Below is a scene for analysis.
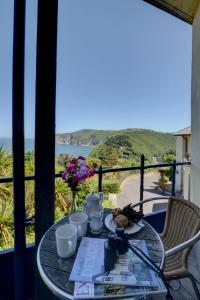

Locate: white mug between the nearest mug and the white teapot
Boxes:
[69,212,88,238]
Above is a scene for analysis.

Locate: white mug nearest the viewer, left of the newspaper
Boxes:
[56,224,77,258]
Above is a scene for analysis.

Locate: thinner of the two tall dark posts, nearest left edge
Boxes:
[12,0,26,300]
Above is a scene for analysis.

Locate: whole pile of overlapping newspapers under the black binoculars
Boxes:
[69,237,166,299]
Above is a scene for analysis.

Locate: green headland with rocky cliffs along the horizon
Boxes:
[56,128,175,157]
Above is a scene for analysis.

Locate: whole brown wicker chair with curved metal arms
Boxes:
[132,196,200,299]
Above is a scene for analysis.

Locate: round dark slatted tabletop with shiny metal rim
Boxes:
[37,209,164,299]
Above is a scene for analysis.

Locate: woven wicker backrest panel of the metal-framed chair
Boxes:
[161,197,200,260]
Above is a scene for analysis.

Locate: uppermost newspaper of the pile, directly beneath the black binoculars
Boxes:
[69,237,158,286]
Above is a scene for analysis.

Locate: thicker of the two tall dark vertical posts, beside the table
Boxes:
[34,0,58,300]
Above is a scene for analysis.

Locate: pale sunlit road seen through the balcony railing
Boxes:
[112,172,166,213]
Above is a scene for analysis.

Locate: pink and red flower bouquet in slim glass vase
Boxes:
[62,156,97,214]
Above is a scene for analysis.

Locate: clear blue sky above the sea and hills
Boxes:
[0,0,192,137]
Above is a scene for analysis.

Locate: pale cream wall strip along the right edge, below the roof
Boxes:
[191,2,200,206]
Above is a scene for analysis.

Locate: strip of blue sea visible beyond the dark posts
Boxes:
[0,137,94,157]
